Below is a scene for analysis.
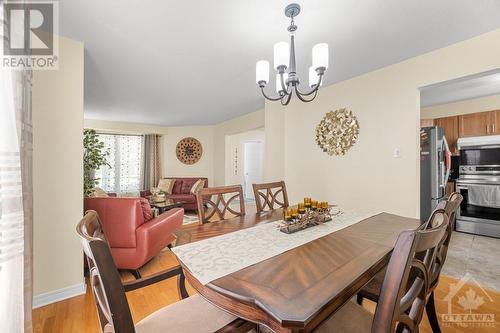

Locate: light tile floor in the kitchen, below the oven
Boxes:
[442,232,500,291]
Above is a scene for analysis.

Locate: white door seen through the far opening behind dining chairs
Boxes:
[243,141,263,199]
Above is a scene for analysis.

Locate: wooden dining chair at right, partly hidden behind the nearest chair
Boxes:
[357,192,463,333]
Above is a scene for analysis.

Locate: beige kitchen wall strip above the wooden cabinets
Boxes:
[421,95,500,119]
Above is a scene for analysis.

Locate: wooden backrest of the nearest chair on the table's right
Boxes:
[372,210,448,333]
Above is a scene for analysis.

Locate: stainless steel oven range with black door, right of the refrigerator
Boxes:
[456,136,500,238]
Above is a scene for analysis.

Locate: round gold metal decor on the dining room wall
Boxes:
[316,108,359,156]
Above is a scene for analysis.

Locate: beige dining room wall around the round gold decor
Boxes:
[265,30,500,217]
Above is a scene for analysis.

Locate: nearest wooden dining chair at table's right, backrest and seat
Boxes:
[316,209,449,333]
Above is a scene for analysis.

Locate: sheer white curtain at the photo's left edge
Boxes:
[0,44,32,332]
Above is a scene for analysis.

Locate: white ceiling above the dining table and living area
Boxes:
[60,0,500,125]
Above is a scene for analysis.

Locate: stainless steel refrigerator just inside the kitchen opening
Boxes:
[420,127,451,221]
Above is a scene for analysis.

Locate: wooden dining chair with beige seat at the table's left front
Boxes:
[76,211,255,333]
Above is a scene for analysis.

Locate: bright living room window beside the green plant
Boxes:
[96,134,143,196]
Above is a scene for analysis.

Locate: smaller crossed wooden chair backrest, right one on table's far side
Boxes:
[253,181,288,213]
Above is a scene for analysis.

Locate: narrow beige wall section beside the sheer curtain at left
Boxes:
[32,38,84,296]
